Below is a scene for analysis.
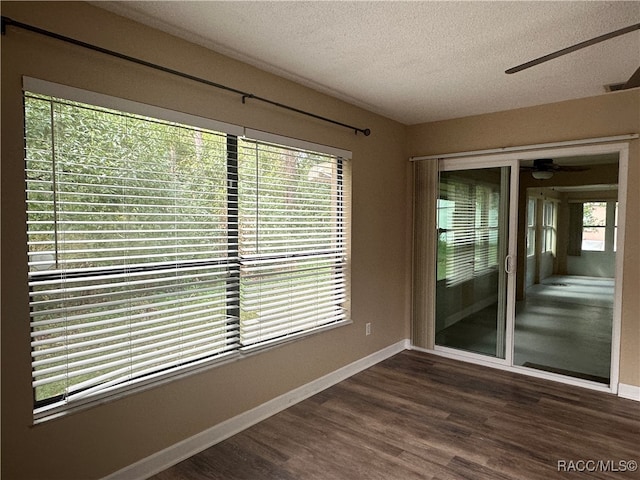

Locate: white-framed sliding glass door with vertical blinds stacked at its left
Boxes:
[411,143,629,393]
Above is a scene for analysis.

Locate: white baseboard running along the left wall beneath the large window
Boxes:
[103,340,410,480]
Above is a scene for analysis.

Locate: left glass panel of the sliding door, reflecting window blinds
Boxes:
[435,167,510,358]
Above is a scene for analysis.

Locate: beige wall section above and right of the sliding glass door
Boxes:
[408,89,640,386]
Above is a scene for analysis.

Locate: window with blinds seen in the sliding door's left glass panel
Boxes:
[437,172,500,286]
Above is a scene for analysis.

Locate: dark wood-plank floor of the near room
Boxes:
[152,351,640,480]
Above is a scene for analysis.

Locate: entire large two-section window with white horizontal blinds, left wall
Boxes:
[24,83,349,416]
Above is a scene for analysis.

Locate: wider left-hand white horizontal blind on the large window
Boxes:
[25,93,239,405]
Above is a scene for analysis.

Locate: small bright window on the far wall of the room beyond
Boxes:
[582,202,618,252]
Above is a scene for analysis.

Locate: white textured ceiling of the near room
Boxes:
[94,1,640,125]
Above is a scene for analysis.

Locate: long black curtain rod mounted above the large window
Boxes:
[2,16,371,137]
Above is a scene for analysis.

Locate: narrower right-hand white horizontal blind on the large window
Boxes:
[238,141,348,347]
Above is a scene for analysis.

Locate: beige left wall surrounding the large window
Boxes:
[2,2,410,480]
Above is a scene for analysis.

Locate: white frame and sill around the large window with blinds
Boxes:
[23,77,351,421]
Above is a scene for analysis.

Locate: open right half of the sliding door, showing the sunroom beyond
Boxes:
[513,153,619,385]
